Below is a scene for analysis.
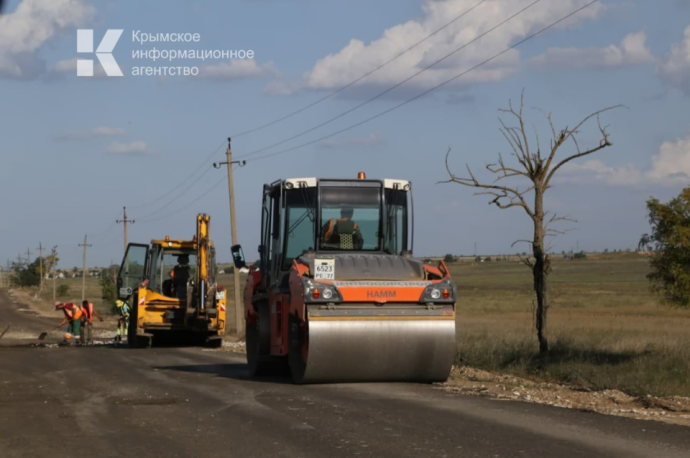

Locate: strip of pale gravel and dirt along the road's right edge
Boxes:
[439,367,690,426]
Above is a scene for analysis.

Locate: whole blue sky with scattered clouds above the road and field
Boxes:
[0,0,690,268]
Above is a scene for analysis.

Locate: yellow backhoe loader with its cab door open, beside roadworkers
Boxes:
[117,214,226,347]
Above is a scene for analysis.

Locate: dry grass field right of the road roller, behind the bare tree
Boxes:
[450,253,690,396]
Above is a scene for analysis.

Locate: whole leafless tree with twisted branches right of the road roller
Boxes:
[442,91,620,353]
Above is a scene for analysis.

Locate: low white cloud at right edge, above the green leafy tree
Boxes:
[556,137,690,186]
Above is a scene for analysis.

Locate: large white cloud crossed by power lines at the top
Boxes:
[298,0,604,95]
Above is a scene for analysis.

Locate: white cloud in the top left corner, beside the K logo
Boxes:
[0,0,95,79]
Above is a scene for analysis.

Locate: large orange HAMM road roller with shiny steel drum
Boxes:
[231,172,457,384]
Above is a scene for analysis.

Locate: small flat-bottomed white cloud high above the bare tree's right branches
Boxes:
[528,32,655,69]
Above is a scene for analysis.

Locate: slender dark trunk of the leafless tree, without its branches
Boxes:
[532,189,549,354]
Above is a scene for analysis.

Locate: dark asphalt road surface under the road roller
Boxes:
[0,293,690,458]
